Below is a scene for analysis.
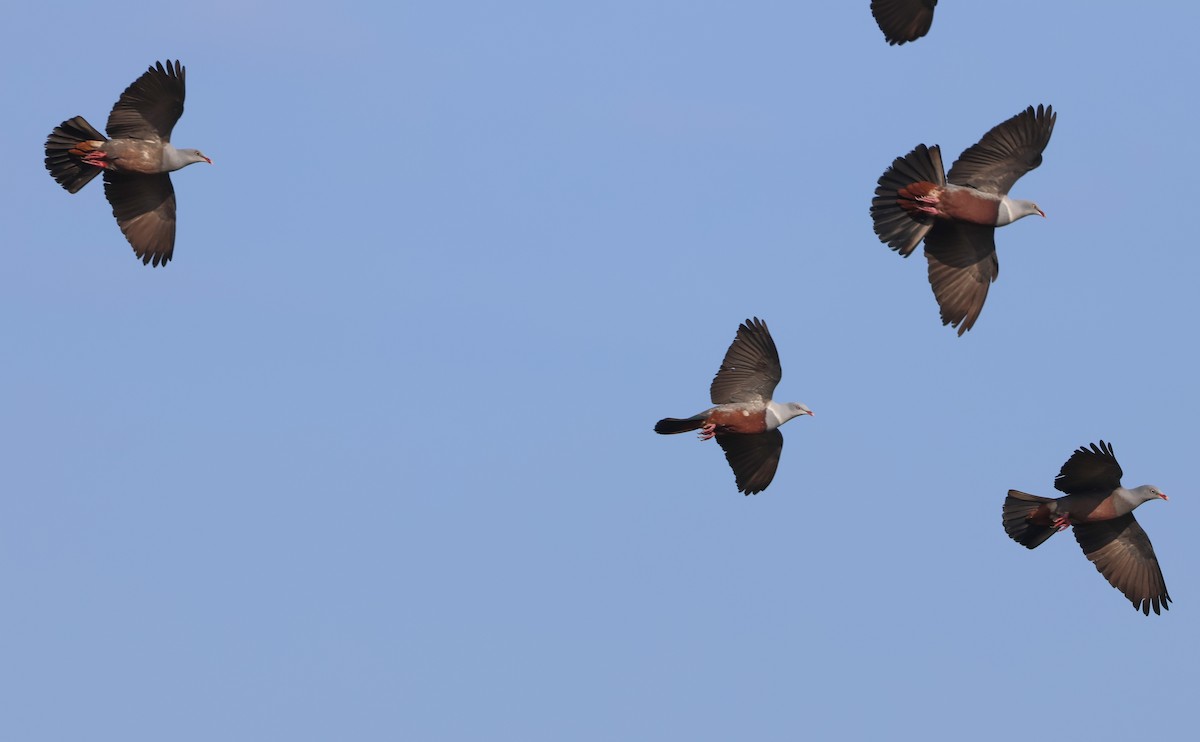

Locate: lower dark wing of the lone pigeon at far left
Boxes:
[104,170,175,268]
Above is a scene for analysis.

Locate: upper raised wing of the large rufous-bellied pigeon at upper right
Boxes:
[946,104,1056,196]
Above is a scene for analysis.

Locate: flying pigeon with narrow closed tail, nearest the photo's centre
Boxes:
[654,317,812,495]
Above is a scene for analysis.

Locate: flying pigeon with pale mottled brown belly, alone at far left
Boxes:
[46,60,212,268]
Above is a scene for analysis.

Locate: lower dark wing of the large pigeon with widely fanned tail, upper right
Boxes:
[925,221,1000,336]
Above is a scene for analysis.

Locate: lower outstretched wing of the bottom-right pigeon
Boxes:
[1075,513,1171,616]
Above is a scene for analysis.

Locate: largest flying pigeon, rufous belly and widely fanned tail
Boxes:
[871,104,1056,336]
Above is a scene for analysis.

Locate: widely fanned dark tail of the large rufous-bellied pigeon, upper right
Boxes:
[871,144,946,257]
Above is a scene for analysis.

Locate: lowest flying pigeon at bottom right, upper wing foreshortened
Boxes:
[1004,441,1171,616]
